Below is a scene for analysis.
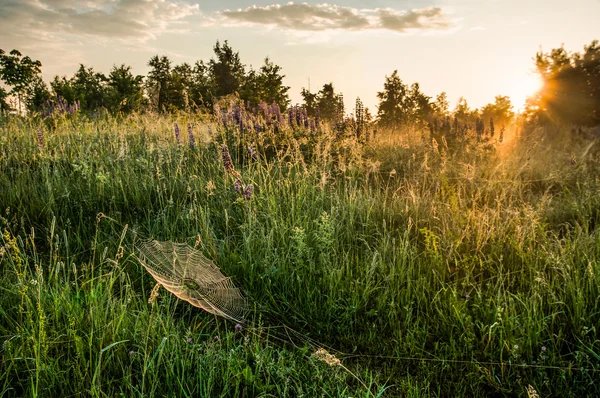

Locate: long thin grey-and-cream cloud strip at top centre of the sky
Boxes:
[221,3,455,33]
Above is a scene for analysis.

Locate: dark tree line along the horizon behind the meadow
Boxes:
[0,40,600,129]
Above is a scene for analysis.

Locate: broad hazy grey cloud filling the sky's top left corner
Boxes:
[0,0,199,47]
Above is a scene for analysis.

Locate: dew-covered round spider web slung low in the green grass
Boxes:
[136,240,248,323]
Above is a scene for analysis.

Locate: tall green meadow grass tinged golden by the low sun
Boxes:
[0,110,600,397]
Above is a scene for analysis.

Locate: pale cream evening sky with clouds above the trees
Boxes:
[0,0,600,112]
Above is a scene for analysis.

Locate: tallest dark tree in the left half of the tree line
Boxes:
[208,40,245,97]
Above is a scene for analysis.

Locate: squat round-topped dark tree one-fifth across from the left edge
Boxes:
[107,64,143,113]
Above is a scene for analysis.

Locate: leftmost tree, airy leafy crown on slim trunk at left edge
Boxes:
[0,50,42,113]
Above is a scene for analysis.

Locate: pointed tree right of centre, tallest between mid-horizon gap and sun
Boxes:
[377,70,408,128]
